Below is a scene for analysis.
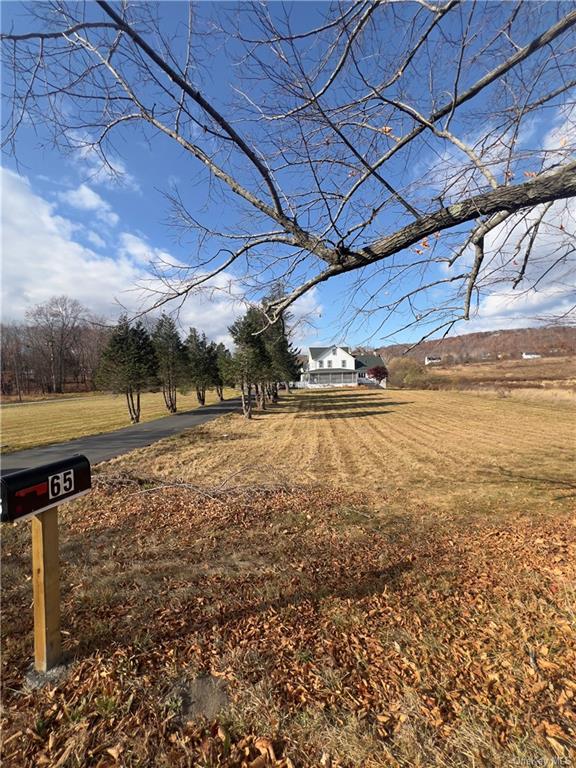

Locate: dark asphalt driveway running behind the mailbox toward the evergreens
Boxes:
[0,398,240,475]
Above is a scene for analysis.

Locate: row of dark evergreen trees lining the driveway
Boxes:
[96,308,298,423]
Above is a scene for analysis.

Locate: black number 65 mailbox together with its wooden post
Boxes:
[0,455,92,672]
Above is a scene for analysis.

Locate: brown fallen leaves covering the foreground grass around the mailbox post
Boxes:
[3,478,576,768]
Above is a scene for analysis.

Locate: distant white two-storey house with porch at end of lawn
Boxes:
[300,345,386,389]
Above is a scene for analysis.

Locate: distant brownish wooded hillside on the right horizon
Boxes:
[377,326,576,364]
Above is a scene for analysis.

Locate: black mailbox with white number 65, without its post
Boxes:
[0,454,92,523]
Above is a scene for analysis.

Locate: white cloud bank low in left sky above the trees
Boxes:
[0,169,264,343]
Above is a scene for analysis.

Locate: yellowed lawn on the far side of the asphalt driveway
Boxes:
[0,390,236,453]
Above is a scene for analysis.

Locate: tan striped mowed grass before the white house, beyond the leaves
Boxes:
[104,389,576,515]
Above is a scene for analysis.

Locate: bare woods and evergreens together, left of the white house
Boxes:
[1,296,299,423]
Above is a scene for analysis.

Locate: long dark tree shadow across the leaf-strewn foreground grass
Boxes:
[57,510,414,657]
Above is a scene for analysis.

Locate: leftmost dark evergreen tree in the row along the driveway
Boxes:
[97,316,158,424]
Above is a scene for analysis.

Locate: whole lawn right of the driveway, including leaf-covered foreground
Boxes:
[2,389,576,768]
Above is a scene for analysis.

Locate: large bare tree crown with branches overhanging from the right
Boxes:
[2,0,576,333]
